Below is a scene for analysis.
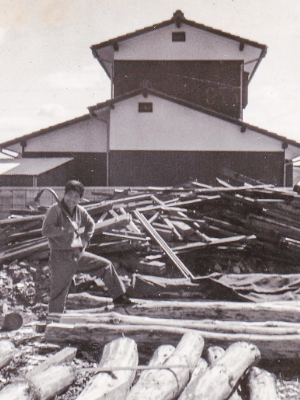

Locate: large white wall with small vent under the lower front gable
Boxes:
[110,95,283,152]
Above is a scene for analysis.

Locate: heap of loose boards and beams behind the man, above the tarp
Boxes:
[0,181,300,278]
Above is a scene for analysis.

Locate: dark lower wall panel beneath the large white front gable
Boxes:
[110,151,283,186]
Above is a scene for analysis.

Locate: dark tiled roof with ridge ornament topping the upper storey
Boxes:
[91,10,267,80]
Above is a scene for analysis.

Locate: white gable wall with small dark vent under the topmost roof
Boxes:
[98,23,261,77]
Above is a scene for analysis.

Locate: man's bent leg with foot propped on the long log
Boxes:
[76,251,126,299]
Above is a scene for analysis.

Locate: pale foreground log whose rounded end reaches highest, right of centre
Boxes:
[126,332,204,400]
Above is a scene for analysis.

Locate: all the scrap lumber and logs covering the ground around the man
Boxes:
[0,180,300,400]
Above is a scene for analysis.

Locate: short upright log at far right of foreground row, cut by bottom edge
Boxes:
[247,367,279,400]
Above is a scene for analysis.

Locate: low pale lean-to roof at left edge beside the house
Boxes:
[0,157,73,176]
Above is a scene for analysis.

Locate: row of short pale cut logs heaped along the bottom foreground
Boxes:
[0,330,299,400]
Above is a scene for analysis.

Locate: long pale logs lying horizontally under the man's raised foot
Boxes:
[45,300,300,360]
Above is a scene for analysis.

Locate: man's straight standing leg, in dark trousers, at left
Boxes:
[49,250,76,313]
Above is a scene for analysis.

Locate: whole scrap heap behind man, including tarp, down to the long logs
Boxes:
[0,181,300,307]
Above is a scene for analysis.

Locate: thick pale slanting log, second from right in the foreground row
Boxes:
[184,342,260,400]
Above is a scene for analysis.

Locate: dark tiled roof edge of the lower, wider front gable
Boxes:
[88,87,300,148]
